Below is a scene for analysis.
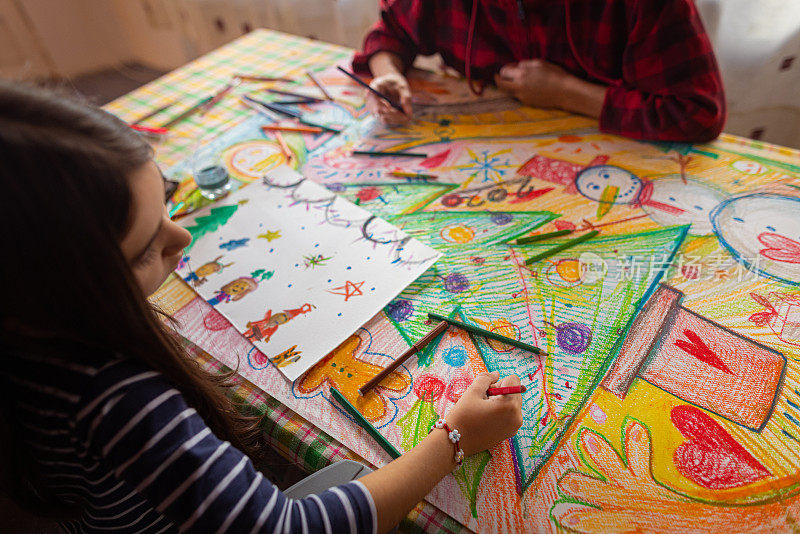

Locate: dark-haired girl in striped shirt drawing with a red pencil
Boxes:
[0,81,522,533]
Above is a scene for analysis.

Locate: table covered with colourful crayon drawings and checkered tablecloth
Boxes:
[107,31,800,532]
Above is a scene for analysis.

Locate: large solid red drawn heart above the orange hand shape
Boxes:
[670,405,770,489]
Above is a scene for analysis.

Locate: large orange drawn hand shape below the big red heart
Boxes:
[550,419,800,534]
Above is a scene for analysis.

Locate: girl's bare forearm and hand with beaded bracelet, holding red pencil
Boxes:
[359,372,522,532]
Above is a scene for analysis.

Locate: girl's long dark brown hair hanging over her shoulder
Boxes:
[0,80,264,510]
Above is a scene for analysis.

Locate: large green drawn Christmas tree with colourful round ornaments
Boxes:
[385,212,686,491]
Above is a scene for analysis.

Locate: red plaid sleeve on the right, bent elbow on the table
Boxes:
[600,0,726,142]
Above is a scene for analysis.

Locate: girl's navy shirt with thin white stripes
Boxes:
[0,349,377,534]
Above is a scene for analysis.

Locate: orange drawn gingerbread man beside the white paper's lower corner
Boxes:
[297,335,411,422]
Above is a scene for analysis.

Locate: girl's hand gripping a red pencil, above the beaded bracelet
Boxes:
[445,371,522,456]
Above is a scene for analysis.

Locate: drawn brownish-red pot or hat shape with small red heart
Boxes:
[601,284,786,431]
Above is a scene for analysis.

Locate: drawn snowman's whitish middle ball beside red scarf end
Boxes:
[642,174,727,235]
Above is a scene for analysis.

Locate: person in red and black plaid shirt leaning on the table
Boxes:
[353,0,726,142]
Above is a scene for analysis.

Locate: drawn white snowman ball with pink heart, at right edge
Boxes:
[711,193,800,285]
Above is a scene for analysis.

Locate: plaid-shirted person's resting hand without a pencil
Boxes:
[494,59,573,108]
